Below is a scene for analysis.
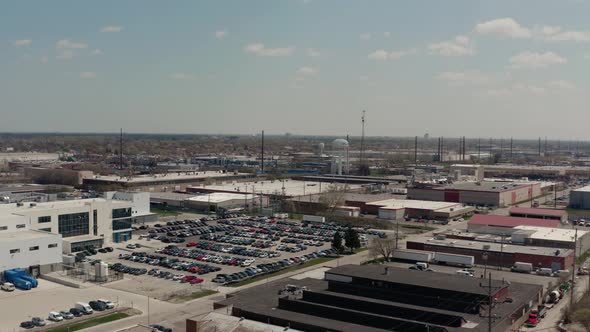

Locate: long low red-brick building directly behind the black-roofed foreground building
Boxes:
[406,236,574,271]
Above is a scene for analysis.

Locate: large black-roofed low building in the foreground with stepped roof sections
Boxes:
[214,265,542,332]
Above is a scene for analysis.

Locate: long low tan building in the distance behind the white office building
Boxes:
[83,171,255,192]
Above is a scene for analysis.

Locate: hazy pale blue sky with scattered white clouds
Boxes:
[0,0,590,139]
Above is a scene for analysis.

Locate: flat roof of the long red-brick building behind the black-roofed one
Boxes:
[408,236,573,257]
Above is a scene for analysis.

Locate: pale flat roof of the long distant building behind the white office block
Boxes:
[87,171,248,183]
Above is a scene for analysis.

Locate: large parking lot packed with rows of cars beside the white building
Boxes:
[89,217,385,300]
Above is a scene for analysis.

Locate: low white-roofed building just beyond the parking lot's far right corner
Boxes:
[367,199,475,220]
